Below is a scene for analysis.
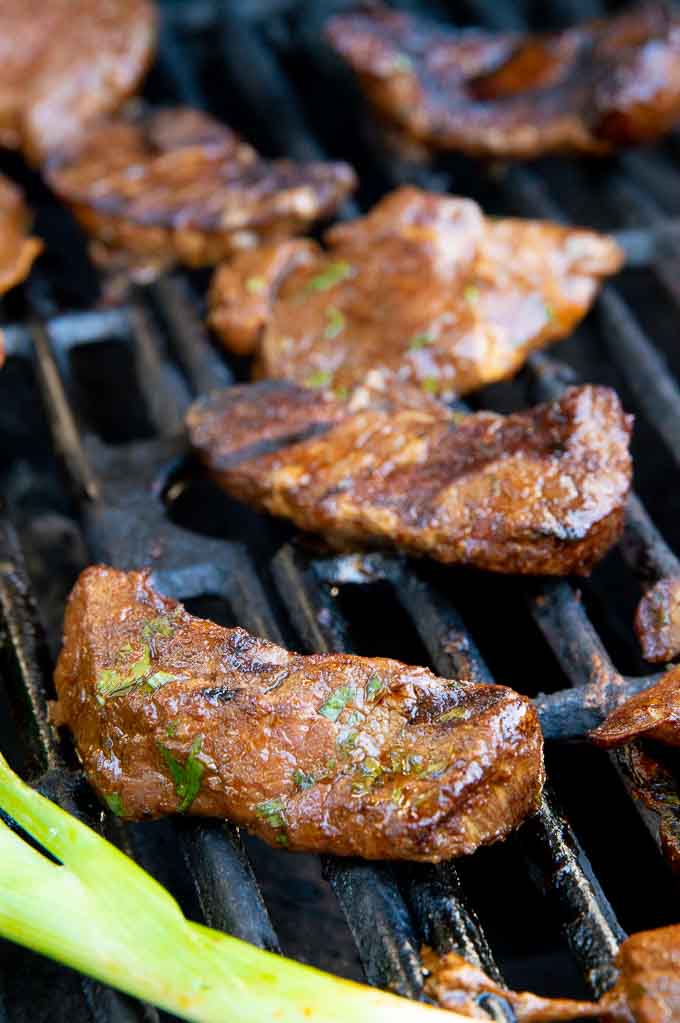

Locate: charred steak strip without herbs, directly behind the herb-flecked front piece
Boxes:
[187,382,631,575]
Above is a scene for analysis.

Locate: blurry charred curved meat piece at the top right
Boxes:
[327,2,680,159]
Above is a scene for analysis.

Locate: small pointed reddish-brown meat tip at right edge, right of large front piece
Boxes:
[590,667,680,747]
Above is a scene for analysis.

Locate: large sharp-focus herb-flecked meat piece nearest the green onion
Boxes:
[54,567,544,861]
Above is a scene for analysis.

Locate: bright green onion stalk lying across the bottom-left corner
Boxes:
[0,756,464,1023]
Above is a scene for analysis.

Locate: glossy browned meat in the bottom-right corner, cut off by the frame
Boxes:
[423,926,680,1023]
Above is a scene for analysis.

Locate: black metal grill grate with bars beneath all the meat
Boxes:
[0,0,680,1023]
